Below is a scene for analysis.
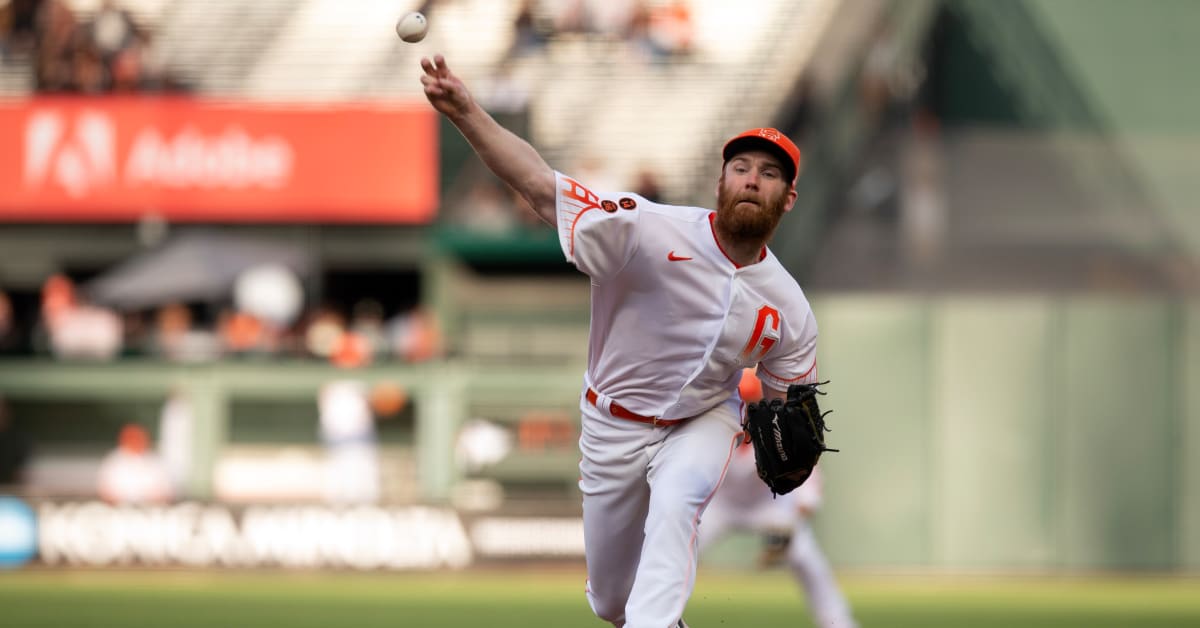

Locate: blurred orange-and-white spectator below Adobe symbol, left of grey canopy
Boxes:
[42,274,124,360]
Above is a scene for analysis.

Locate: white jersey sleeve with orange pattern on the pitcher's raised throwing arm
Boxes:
[554,172,641,279]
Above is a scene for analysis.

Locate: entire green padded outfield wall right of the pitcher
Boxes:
[816,297,1200,570]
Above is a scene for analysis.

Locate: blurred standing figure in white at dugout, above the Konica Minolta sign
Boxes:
[317,379,379,504]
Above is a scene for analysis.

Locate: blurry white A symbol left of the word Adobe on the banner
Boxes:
[24,110,116,198]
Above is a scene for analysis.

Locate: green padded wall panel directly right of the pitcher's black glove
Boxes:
[815,297,934,566]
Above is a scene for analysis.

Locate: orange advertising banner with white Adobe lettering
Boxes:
[0,98,438,223]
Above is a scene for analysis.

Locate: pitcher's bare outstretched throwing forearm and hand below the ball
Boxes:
[421,54,554,225]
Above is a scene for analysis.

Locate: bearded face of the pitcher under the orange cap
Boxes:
[716,150,796,240]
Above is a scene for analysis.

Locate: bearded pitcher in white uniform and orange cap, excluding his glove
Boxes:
[421,55,817,628]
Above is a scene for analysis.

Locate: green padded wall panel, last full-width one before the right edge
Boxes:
[1056,299,1176,569]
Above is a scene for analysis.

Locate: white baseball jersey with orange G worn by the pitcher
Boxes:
[556,173,817,419]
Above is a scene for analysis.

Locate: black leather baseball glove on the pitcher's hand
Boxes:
[742,382,836,495]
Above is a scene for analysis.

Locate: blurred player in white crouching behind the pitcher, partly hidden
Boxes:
[700,369,858,628]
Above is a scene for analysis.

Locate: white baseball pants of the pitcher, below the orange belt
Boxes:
[580,395,740,628]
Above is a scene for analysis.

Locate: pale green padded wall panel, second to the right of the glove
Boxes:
[930,298,1055,569]
